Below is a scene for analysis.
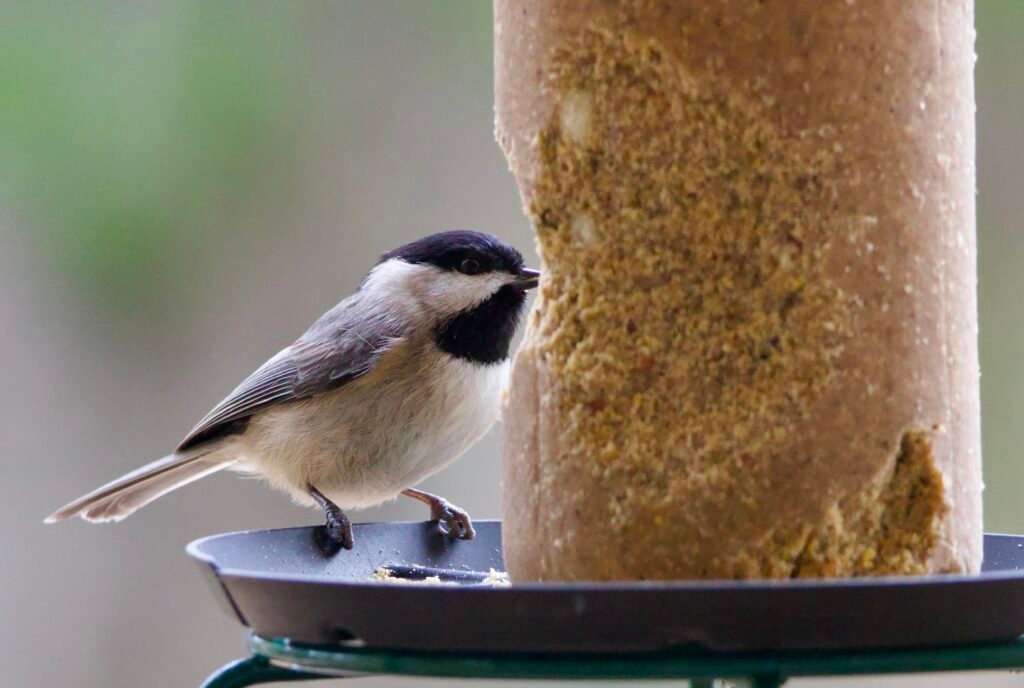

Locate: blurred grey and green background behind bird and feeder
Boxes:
[0,0,1024,688]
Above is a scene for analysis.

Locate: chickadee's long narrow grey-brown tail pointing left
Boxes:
[46,447,236,523]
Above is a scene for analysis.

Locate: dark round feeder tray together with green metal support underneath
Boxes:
[188,521,1024,688]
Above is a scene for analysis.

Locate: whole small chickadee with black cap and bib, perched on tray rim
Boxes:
[46,231,540,549]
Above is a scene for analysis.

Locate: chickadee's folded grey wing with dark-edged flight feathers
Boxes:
[178,321,402,452]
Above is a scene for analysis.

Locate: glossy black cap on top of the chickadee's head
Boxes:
[381,230,523,274]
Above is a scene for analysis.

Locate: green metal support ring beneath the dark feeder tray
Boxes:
[203,635,1024,688]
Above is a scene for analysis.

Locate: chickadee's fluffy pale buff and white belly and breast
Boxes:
[234,353,508,508]
